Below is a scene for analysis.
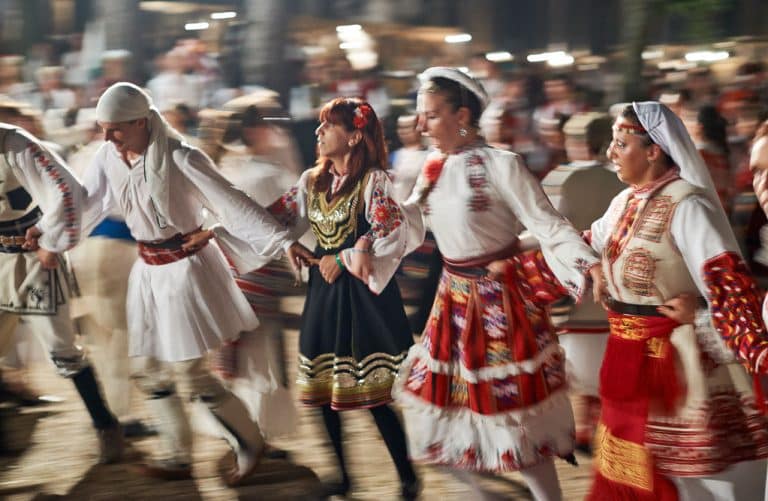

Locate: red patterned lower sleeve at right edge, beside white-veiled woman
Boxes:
[703,252,768,372]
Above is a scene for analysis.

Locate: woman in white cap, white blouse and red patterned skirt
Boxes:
[395,67,600,500]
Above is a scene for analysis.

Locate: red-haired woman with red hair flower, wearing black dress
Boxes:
[270,98,419,499]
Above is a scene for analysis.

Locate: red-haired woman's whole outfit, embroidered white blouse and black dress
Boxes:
[269,166,413,410]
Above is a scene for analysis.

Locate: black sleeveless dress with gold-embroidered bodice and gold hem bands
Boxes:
[297,176,413,410]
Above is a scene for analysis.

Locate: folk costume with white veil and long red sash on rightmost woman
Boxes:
[589,102,768,500]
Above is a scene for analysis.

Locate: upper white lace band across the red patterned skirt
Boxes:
[401,343,565,384]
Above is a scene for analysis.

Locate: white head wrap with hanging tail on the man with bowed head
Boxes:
[96,82,181,228]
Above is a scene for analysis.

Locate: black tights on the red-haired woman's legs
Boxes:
[322,405,416,485]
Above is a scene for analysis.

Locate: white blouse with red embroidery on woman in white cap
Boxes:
[404,145,599,297]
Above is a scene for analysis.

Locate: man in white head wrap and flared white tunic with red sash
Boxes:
[83,82,298,485]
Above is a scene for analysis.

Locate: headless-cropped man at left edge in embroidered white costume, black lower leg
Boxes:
[0,117,123,463]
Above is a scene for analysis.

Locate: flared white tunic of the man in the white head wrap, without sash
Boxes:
[83,142,287,361]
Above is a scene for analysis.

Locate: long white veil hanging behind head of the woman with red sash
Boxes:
[632,101,739,250]
